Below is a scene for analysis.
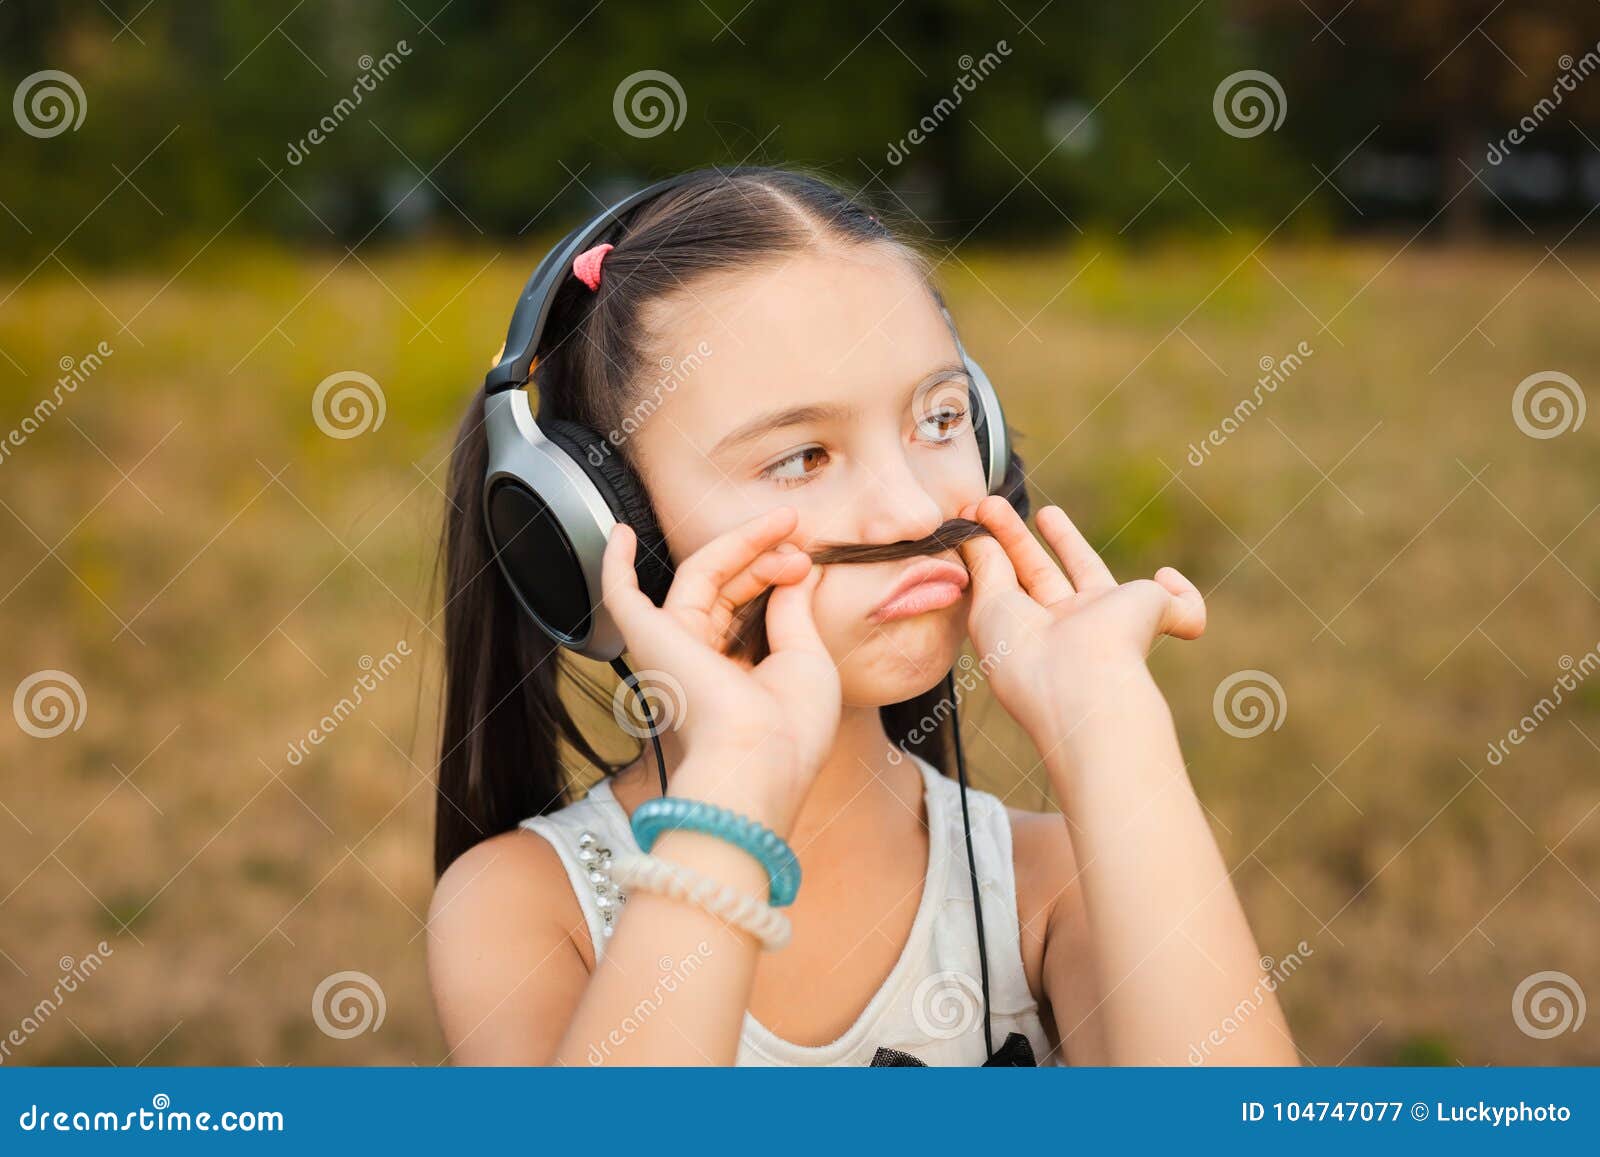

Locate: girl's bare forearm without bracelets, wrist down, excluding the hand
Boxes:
[1038,664,1298,1064]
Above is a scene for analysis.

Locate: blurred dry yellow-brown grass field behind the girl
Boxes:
[0,237,1600,1064]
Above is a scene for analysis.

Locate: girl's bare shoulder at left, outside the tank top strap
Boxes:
[427,827,594,1064]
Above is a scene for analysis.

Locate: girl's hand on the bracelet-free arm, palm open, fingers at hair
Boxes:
[960,494,1205,751]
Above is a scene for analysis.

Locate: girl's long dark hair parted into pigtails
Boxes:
[434,166,1027,874]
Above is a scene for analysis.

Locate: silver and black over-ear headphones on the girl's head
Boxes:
[483,173,1011,663]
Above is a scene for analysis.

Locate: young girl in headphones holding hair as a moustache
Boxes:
[429,168,1296,1066]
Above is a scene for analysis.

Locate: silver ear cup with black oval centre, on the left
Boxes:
[483,389,622,661]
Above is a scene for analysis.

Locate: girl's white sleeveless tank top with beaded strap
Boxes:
[522,755,1050,1066]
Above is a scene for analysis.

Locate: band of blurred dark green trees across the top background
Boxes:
[25,0,1574,264]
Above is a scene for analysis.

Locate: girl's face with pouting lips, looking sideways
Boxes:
[626,246,986,706]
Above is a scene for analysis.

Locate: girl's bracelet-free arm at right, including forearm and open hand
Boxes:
[962,498,1298,1064]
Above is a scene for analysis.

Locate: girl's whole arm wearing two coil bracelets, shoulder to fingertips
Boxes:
[429,507,840,1064]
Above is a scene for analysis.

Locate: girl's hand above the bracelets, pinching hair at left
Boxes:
[602,507,840,819]
